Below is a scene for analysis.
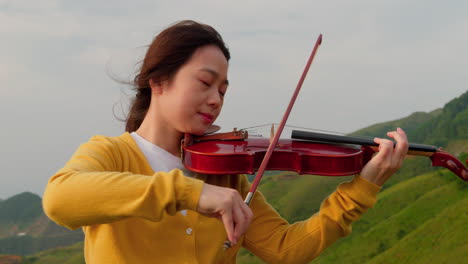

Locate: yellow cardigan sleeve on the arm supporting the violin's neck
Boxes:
[243,176,380,263]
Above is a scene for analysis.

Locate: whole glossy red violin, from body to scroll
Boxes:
[182,127,468,181]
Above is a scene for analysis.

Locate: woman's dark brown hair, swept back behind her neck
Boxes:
[125,20,231,132]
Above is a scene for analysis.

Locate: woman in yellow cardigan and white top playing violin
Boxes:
[43,21,408,264]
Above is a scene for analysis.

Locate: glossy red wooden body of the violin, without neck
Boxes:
[182,138,373,176]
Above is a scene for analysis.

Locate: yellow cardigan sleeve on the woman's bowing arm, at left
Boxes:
[43,137,203,229]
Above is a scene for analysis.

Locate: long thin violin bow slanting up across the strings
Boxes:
[224,34,322,249]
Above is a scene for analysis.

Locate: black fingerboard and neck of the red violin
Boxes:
[291,130,438,157]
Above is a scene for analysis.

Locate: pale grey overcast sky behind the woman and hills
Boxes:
[0,0,468,199]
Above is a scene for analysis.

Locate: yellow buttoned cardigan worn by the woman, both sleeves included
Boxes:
[43,133,380,264]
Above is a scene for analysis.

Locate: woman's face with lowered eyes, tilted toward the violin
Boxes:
[155,45,228,135]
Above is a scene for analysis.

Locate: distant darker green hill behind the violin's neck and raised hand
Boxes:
[350,91,468,188]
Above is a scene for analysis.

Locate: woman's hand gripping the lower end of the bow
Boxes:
[197,183,253,245]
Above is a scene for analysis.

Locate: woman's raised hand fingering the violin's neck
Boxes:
[361,128,408,186]
